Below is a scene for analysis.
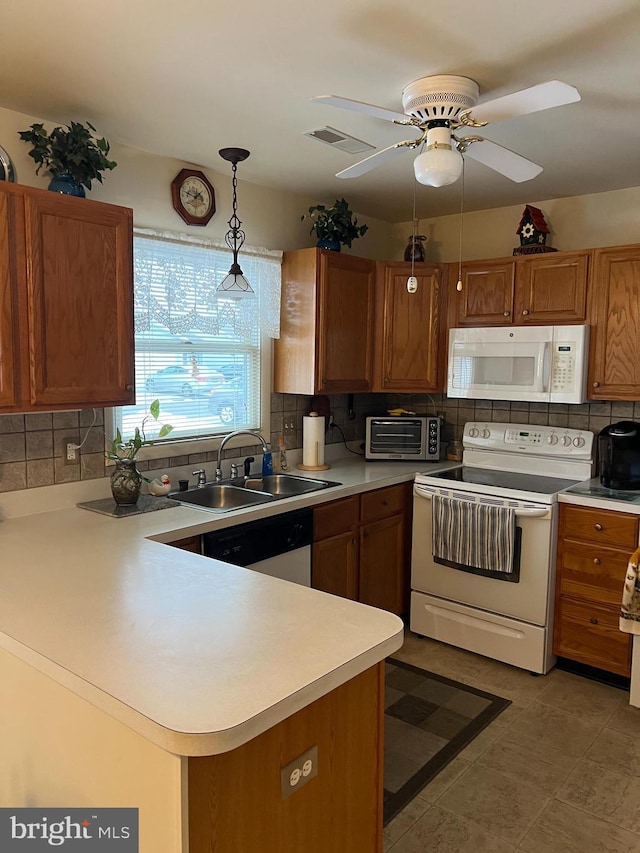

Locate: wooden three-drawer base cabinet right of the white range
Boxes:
[553,504,639,677]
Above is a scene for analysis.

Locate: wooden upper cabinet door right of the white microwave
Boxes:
[587,245,640,400]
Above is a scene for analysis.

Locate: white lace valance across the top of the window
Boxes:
[134,228,282,340]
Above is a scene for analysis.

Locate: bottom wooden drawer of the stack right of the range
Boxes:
[553,597,631,676]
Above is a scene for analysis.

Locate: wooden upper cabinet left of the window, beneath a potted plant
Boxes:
[0,182,135,412]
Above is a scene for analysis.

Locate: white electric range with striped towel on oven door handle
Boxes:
[410,422,594,673]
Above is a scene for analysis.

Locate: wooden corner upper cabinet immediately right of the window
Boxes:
[274,249,375,394]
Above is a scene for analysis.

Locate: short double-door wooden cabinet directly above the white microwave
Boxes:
[449,252,590,326]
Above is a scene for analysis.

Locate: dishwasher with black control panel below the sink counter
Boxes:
[202,509,313,586]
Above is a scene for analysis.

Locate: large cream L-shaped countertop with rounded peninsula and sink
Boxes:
[0,459,451,755]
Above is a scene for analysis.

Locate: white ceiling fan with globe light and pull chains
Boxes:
[312,74,580,187]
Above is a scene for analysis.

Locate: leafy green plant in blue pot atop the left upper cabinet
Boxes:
[18,121,117,196]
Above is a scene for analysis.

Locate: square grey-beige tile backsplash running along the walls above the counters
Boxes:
[0,394,640,492]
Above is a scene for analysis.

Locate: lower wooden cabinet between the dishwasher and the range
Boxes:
[311,483,412,615]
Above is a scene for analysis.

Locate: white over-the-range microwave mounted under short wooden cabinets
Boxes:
[447,326,589,403]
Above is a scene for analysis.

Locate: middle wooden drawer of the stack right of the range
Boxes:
[558,539,630,607]
